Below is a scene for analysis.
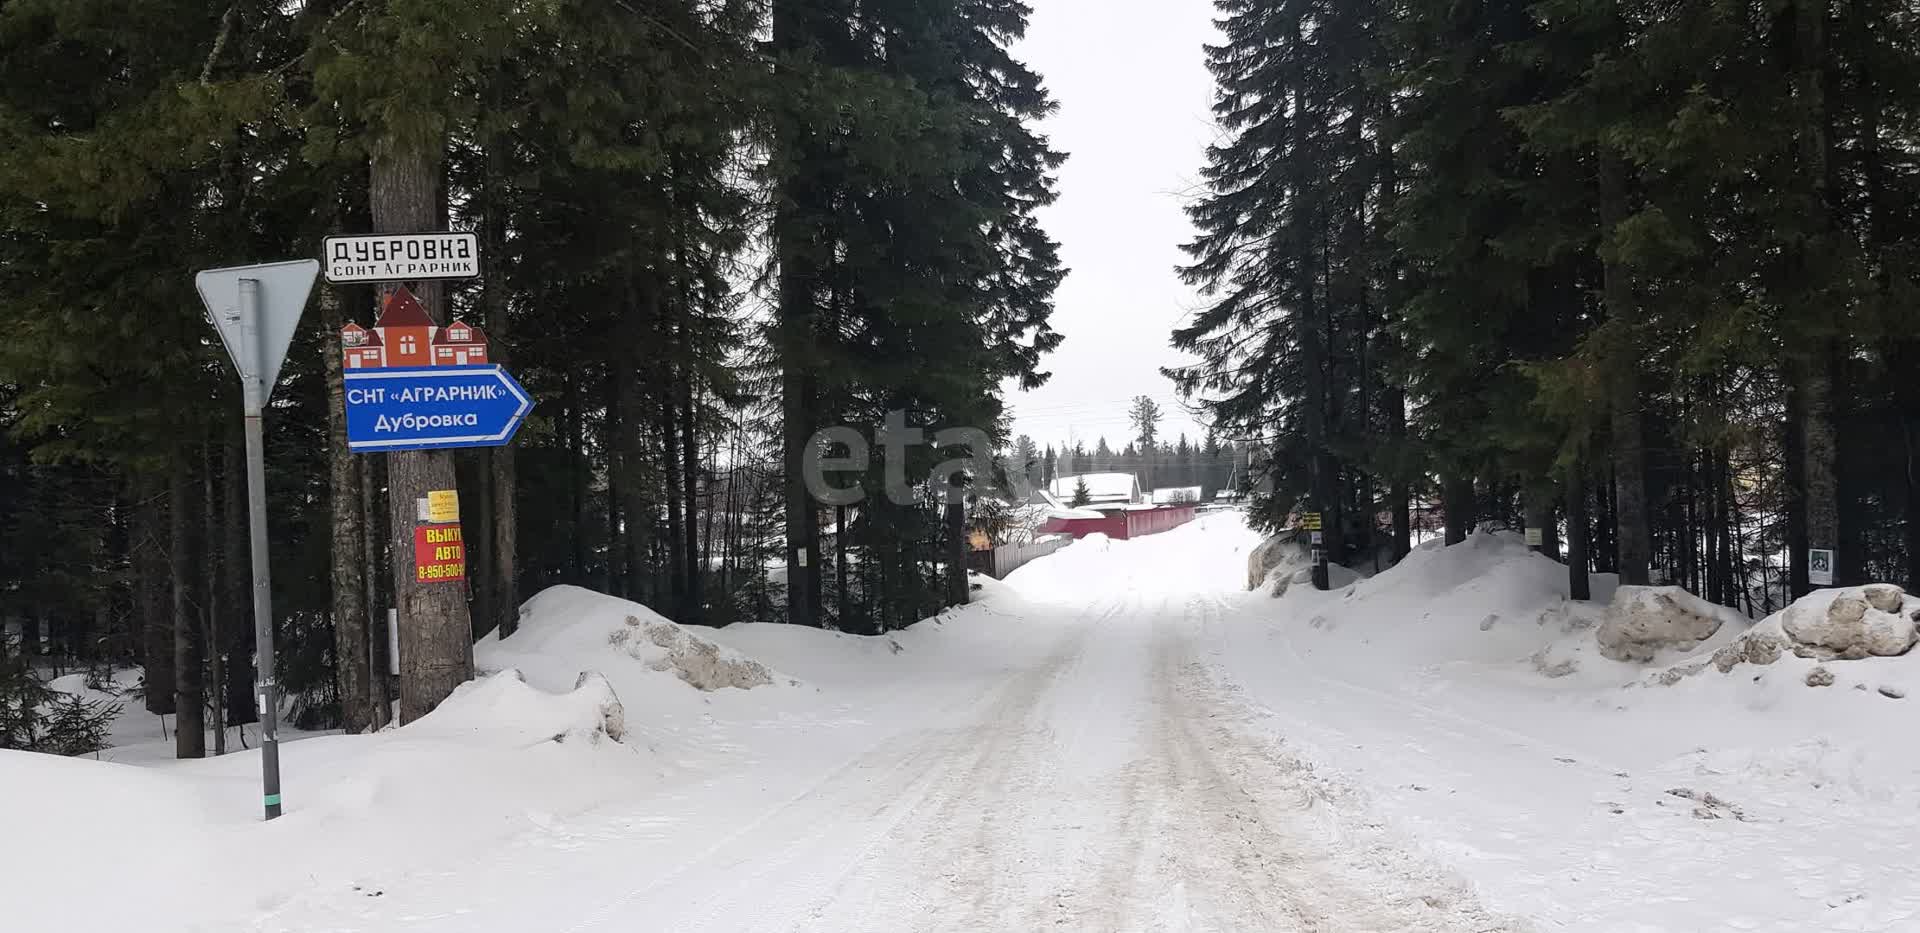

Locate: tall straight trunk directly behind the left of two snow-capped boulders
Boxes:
[1599,152,1653,586]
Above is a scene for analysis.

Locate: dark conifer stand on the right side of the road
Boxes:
[1169,0,1920,614]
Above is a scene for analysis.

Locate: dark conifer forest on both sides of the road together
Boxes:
[0,0,1920,756]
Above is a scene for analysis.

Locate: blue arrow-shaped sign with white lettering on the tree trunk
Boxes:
[346,367,534,453]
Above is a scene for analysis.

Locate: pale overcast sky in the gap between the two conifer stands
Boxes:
[1008,0,1213,449]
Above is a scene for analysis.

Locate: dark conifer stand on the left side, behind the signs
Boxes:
[0,0,1064,756]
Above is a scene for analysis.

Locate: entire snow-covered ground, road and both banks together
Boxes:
[0,514,1920,933]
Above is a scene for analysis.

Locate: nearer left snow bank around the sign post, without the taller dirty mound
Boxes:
[0,656,668,931]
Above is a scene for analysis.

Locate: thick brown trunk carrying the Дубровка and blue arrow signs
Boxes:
[371,140,474,722]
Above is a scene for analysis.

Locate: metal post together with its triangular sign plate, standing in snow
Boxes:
[194,259,321,820]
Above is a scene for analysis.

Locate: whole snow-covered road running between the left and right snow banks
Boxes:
[261,533,1507,933]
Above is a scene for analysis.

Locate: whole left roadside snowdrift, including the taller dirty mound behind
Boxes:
[0,587,806,929]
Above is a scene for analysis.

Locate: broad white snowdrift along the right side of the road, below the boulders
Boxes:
[1221,534,1920,933]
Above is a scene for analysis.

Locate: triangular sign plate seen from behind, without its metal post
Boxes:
[194,259,321,411]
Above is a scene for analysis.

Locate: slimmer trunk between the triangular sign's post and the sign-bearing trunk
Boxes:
[321,286,372,735]
